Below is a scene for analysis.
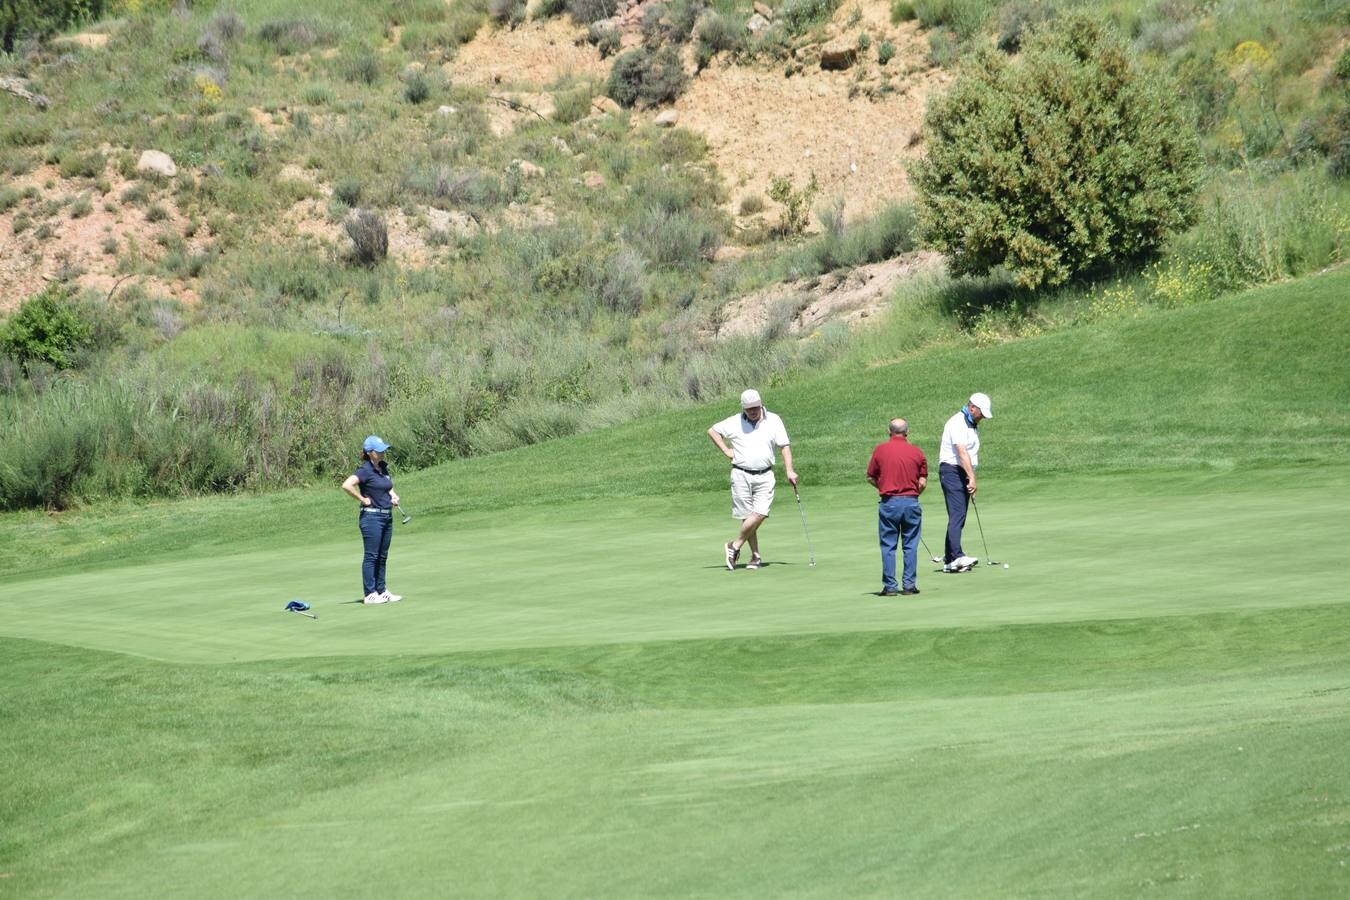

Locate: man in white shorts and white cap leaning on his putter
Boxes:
[707,390,797,572]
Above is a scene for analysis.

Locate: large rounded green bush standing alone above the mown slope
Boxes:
[915,16,1200,287]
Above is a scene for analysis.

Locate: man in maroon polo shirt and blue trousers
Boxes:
[867,418,927,596]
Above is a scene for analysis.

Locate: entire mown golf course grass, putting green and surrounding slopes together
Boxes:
[0,274,1350,897]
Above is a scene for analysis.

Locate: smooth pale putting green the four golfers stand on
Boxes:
[0,470,1350,663]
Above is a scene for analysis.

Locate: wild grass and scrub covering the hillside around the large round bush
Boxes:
[0,0,1350,509]
